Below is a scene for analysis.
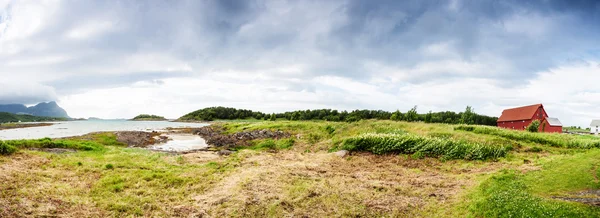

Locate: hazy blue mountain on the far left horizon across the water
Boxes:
[0,101,69,118]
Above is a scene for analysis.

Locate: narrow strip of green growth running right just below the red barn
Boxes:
[454,125,600,149]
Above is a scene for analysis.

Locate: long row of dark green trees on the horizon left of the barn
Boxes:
[179,106,498,126]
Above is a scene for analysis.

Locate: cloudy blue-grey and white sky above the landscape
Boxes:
[0,0,600,126]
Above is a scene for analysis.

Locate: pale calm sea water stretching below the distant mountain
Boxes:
[0,120,208,140]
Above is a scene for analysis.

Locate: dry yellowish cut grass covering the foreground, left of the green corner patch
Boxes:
[0,147,510,217]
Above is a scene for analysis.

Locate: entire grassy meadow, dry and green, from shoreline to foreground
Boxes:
[0,120,600,217]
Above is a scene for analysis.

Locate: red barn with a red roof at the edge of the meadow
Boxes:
[497,104,562,133]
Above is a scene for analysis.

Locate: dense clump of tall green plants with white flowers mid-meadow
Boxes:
[343,133,512,160]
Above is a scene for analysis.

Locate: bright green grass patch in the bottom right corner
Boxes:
[471,149,600,217]
